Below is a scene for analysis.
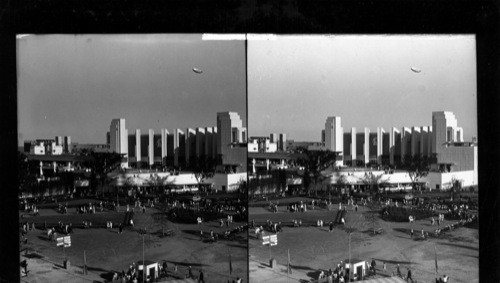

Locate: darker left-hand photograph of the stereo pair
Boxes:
[16,34,248,282]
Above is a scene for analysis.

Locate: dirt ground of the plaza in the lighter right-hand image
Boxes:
[249,207,479,282]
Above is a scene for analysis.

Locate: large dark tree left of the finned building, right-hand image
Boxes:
[295,147,339,195]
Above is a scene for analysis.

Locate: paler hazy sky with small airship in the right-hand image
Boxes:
[248,35,477,141]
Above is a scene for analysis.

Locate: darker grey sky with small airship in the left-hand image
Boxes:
[17,35,246,144]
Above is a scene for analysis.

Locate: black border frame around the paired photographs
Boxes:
[0,0,500,282]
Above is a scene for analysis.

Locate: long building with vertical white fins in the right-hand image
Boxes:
[322,111,473,172]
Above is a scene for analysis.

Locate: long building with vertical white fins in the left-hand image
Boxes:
[111,112,247,170]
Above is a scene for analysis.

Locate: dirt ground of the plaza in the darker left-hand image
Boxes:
[21,206,248,282]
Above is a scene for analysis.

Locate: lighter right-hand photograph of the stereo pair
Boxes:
[247,34,479,283]
